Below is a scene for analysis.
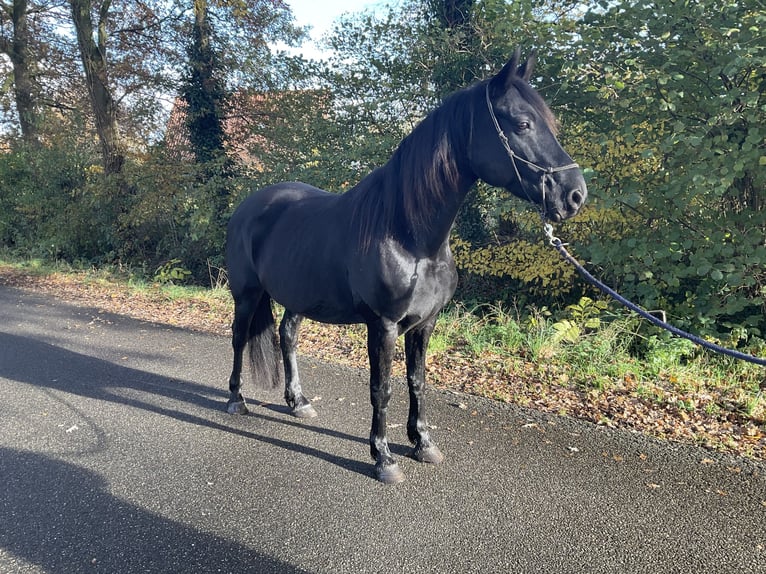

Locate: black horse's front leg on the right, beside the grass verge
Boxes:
[404,318,444,464]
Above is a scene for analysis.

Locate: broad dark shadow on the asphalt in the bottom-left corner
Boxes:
[0,447,312,574]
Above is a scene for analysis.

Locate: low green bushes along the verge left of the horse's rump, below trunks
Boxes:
[0,139,241,281]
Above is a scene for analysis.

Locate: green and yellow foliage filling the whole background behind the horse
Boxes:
[0,0,766,346]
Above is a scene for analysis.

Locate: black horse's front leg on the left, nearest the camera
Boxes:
[367,319,404,484]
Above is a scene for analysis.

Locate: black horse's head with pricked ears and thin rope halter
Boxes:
[469,49,588,221]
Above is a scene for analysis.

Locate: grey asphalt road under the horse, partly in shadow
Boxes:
[0,288,766,574]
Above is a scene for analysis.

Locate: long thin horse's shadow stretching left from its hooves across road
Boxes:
[0,332,408,477]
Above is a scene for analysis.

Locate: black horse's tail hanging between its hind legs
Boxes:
[248,293,284,389]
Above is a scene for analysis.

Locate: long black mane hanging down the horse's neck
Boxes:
[346,84,473,249]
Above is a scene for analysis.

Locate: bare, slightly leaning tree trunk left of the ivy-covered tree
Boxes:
[70,0,125,175]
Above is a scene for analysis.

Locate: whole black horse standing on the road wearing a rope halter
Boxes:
[226,50,587,483]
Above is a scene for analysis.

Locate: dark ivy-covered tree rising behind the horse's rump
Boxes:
[170,0,299,270]
